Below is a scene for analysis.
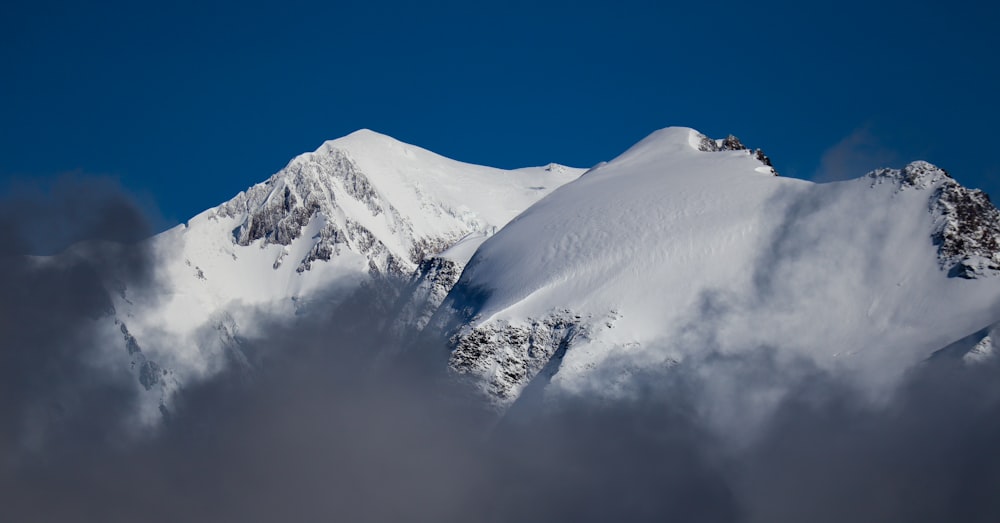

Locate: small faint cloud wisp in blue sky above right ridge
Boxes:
[812,125,899,182]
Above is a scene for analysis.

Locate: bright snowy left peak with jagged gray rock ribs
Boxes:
[102,130,583,422]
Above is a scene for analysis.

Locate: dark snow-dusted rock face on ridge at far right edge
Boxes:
[868,161,1000,279]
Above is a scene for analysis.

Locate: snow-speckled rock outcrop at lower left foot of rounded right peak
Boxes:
[448,309,590,409]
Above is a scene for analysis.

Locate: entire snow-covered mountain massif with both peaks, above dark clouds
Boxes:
[86,128,1000,420]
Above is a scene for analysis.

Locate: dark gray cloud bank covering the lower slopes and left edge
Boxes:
[0,179,1000,523]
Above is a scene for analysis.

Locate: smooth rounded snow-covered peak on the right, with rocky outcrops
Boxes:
[434,128,1000,408]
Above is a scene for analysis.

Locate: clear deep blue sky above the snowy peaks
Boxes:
[0,0,1000,227]
